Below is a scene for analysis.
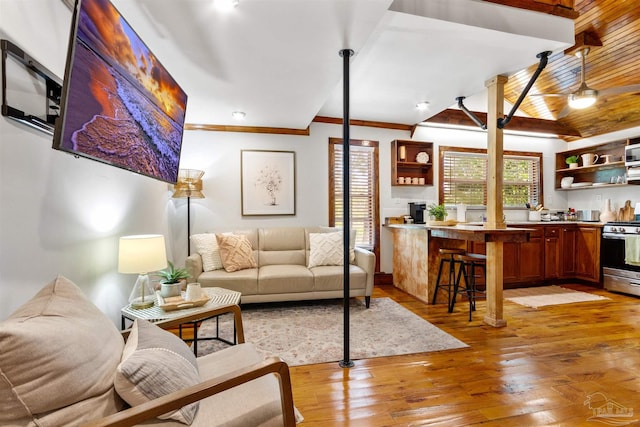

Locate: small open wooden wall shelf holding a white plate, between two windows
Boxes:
[391,139,434,187]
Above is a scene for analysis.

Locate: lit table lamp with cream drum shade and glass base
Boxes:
[118,234,167,309]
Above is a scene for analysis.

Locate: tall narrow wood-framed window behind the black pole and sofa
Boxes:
[329,138,380,259]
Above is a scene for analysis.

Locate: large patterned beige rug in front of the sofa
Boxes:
[198,298,468,366]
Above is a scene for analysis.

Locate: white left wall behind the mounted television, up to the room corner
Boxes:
[0,0,172,324]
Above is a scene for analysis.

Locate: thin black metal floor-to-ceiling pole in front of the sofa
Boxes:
[339,49,354,368]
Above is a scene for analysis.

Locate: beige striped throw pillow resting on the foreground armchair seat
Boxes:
[115,319,200,424]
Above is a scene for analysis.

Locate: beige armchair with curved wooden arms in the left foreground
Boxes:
[0,277,299,426]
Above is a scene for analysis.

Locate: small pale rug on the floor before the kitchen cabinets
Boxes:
[503,286,609,308]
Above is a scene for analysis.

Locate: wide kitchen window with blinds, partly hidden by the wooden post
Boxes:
[439,147,542,208]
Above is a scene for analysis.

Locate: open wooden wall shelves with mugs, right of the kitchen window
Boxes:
[555,140,628,190]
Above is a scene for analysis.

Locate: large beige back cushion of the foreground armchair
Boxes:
[0,276,124,426]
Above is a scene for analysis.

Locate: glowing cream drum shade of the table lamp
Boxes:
[118,234,167,274]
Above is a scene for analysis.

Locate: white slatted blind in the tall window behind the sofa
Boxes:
[330,144,377,250]
